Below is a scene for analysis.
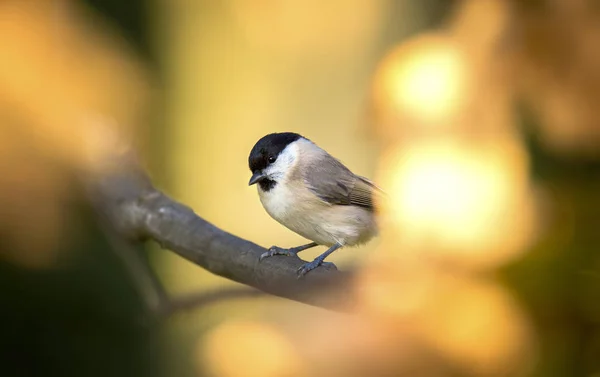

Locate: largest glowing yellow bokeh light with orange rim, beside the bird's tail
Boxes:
[382,137,532,266]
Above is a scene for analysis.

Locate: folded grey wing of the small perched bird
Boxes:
[303,155,381,210]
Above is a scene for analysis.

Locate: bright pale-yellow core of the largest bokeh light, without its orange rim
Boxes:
[396,141,507,238]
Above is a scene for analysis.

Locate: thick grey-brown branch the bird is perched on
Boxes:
[91,154,354,311]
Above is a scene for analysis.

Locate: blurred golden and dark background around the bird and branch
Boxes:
[0,0,600,377]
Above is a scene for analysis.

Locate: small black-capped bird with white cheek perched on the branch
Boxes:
[248,132,382,278]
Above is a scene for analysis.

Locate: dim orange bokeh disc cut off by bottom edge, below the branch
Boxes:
[199,321,302,377]
